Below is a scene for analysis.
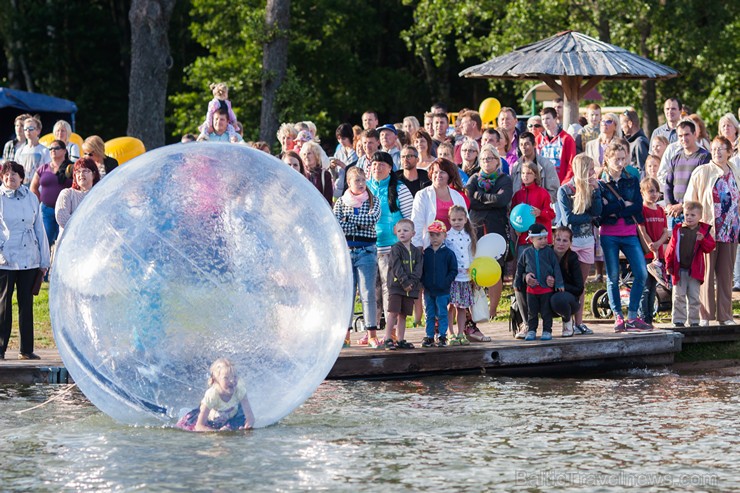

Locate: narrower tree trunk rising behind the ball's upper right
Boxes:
[260,0,290,145]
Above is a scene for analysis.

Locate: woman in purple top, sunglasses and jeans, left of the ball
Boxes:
[31,140,72,247]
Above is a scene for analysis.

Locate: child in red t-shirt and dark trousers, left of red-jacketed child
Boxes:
[638,177,671,325]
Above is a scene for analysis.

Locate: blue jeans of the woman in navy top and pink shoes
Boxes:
[601,235,647,318]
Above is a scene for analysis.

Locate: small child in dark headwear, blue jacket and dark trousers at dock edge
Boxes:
[514,223,564,341]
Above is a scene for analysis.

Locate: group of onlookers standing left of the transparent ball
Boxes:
[0,114,118,359]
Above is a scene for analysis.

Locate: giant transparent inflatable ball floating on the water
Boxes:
[49,143,352,427]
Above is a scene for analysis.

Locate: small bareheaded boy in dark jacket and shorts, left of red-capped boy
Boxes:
[385,219,424,350]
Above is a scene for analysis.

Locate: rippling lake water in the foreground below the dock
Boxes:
[0,370,740,492]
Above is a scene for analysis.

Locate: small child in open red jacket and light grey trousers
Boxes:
[665,201,715,327]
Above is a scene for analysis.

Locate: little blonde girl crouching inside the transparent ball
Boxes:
[176,358,254,431]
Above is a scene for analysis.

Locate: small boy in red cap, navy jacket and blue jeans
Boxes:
[421,221,457,347]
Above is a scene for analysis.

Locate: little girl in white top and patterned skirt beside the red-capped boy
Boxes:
[445,205,476,346]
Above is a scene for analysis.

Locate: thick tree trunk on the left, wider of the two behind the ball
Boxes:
[126,0,176,150]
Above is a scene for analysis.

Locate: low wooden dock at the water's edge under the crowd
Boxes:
[0,321,740,384]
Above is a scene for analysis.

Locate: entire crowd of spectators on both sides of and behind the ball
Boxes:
[0,84,740,359]
